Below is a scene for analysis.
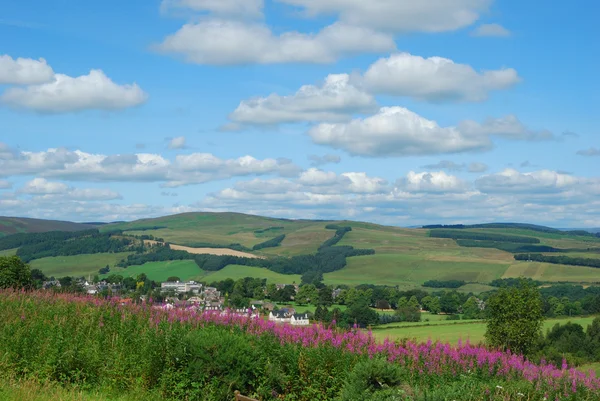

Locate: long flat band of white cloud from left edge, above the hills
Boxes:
[0,144,300,187]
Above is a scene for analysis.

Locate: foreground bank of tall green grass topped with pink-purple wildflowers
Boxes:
[0,291,600,401]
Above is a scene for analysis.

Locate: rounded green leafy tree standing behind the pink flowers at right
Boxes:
[485,281,544,355]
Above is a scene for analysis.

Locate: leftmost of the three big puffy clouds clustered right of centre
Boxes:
[229,74,377,124]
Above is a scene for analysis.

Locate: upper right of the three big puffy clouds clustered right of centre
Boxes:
[362,53,520,102]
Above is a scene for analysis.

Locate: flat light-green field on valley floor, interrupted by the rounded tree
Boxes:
[373,317,594,344]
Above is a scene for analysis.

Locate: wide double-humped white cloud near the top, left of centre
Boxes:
[156,19,395,65]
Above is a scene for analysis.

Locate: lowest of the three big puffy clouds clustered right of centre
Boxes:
[309,107,492,156]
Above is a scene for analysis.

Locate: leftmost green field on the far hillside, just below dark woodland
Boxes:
[29,252,131,277]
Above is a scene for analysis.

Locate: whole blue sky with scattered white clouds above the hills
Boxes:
[0,0,600,227]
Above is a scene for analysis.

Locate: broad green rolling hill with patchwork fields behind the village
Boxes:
[1,213,600,292]
